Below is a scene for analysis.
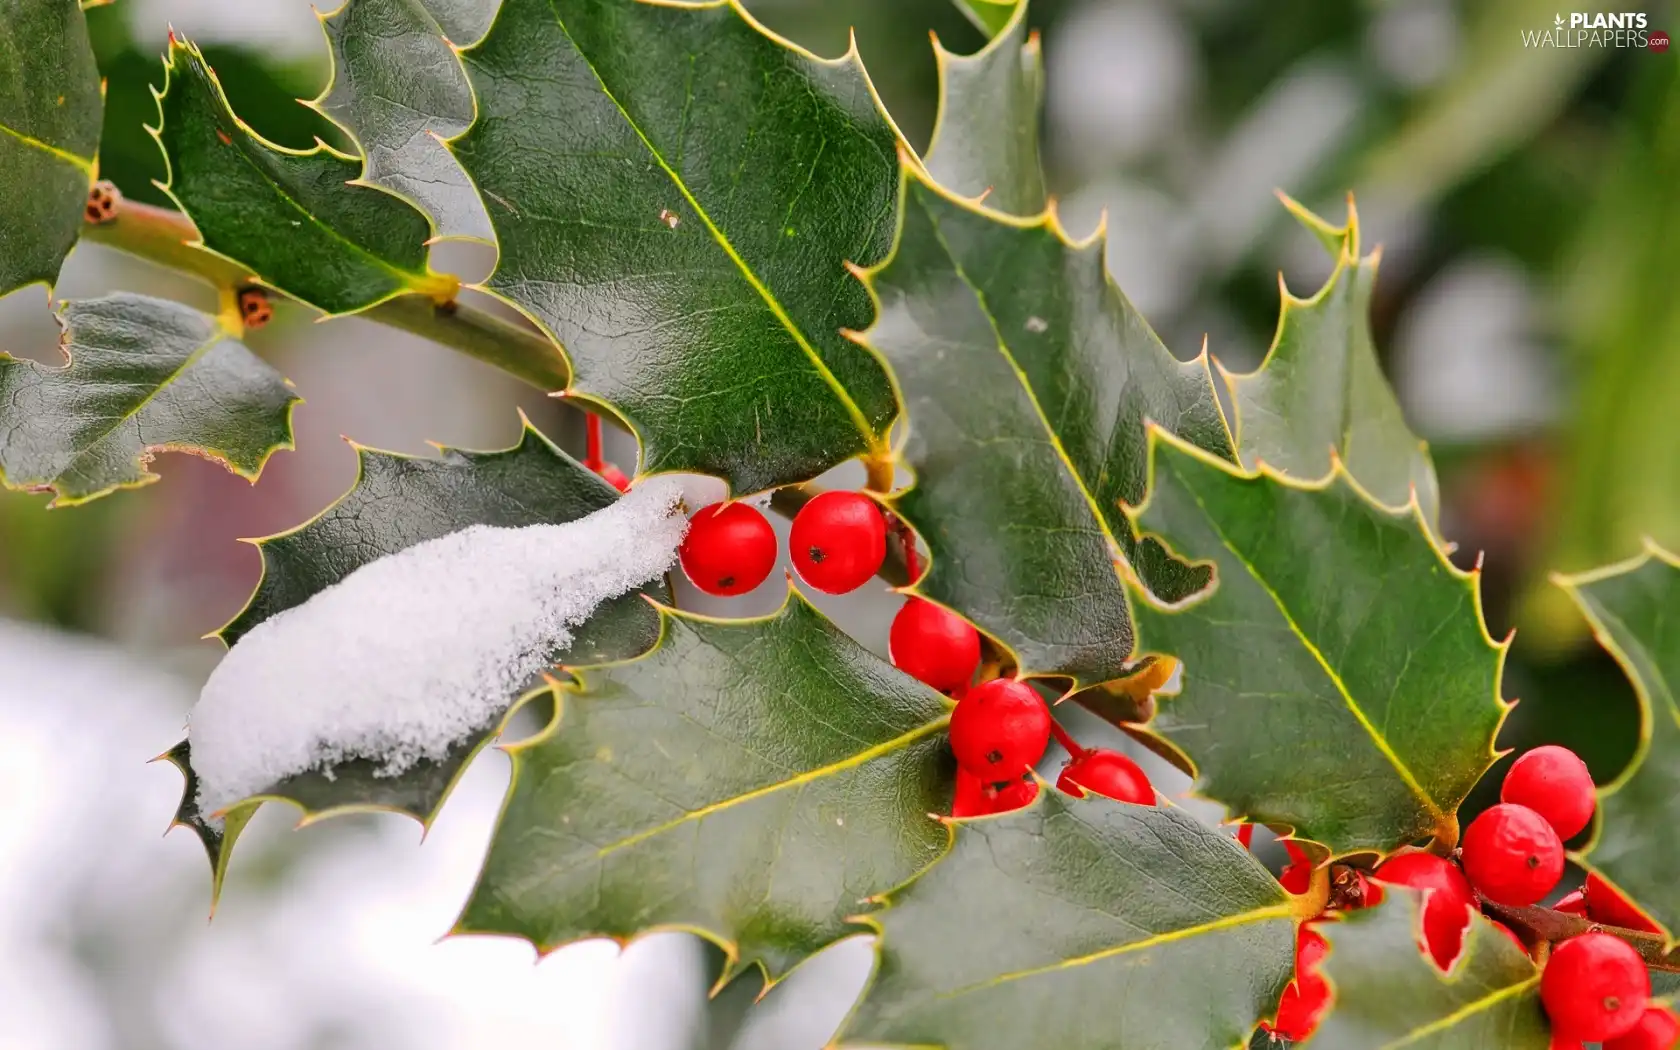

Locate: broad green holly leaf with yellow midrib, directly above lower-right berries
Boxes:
[1134,430,1509,855]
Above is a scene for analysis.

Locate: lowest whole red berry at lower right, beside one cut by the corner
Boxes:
[1541,934,1651,1043]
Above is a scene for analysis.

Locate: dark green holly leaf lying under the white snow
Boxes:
[168,422,669,889]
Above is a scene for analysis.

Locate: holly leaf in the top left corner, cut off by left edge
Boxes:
[0,0,104,296]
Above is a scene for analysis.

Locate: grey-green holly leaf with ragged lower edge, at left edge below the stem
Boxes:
[0,292,301,507]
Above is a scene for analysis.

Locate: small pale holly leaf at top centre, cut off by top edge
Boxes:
[926,3,1048,215]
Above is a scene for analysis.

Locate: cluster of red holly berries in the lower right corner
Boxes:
[1245,746,1680,1050]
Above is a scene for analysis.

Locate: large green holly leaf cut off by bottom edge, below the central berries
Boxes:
[842,786,1295,1050]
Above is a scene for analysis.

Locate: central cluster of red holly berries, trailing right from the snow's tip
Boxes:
[679,492,1154,816]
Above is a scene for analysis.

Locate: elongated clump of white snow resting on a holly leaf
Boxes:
[186,479,687,825]
